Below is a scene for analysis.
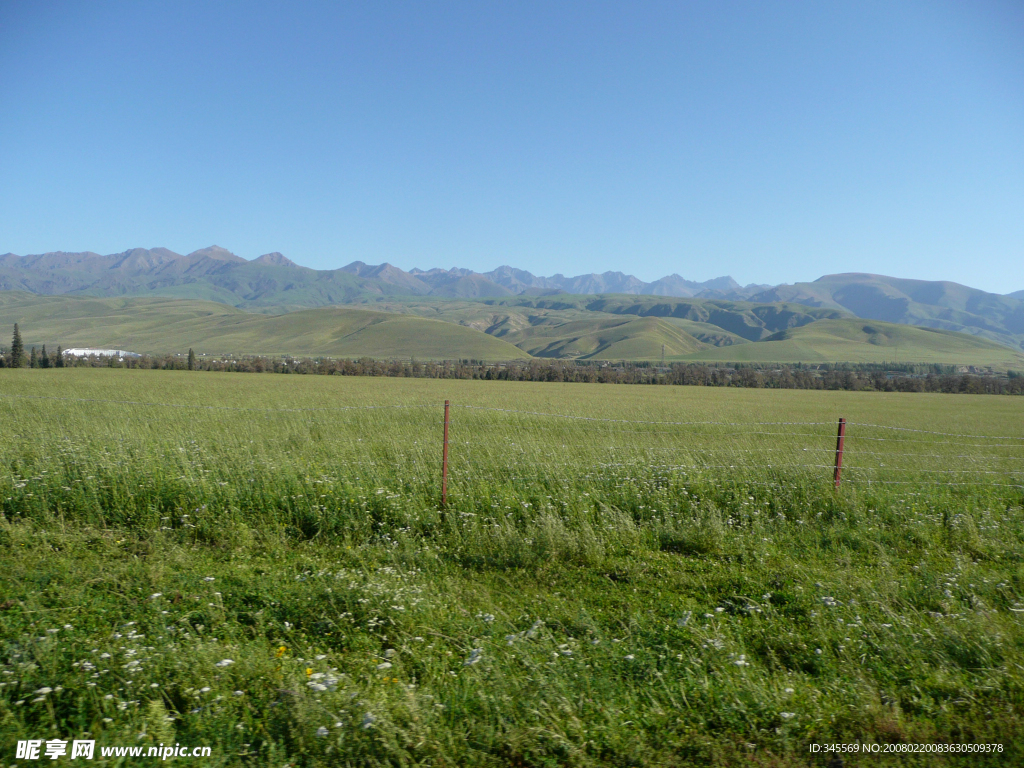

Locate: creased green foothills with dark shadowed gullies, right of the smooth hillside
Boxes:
[348,295,1024,369]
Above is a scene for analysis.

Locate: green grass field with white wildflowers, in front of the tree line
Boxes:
[0,369,1024,766]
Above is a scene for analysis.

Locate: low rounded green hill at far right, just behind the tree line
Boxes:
[686,319,1024,369]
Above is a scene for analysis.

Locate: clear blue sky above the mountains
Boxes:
[0,0,1024,293]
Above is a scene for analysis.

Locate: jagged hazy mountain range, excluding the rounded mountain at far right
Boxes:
[0,246,771,306]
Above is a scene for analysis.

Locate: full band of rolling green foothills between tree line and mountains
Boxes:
[8,292,1024,371]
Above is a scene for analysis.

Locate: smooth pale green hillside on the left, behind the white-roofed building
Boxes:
[0,293,528,360]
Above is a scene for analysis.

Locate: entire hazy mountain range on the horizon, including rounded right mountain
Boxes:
[6,246,1024,354]
